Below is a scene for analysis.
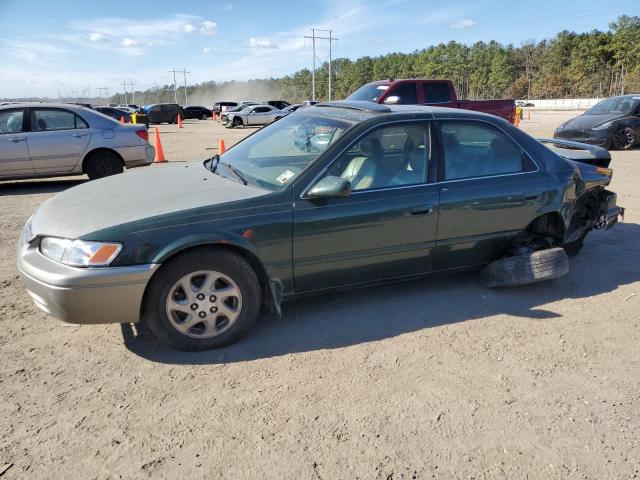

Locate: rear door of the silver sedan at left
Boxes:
[27,107,91,174]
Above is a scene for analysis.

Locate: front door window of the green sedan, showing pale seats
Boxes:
[327,123,431,192]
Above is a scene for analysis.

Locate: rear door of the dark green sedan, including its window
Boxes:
[434,120,547,269]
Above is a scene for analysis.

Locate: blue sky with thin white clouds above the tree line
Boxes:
[0,0,640,97]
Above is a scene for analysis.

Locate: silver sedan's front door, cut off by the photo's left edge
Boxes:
[0,108,34,177]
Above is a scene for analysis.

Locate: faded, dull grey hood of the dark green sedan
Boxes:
[31,162,270,239]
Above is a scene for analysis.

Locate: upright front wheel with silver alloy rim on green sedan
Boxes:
[142,248,262,351]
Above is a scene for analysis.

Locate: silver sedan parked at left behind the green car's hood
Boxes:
[0,103,155,180]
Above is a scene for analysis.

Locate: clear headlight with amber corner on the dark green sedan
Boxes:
[40,237,122,267]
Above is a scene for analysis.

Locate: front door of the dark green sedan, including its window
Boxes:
[293,121,438,292]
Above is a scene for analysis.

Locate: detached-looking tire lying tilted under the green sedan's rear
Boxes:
[480,248,569,288]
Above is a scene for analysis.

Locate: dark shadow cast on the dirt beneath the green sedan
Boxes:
[122,224,640,364]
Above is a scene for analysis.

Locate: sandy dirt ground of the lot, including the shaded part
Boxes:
[0,112,640,480]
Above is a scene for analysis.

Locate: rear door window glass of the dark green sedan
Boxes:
[440,122,533,180]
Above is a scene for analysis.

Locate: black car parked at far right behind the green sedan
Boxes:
[553,94,640,150]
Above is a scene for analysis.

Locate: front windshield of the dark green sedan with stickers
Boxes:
[209,114,350,191]
